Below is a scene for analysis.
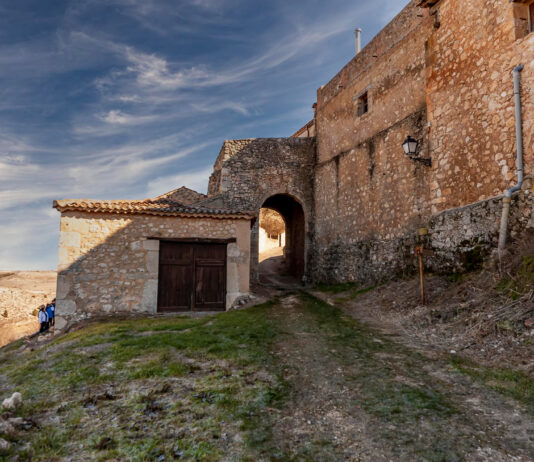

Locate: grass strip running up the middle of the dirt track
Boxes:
[304,295,470,461]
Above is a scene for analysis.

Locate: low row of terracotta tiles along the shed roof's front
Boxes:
[54,198,256,220]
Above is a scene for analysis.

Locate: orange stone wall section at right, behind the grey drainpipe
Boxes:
[427,0,534,212]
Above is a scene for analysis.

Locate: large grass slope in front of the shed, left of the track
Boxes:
[0,301,286,461]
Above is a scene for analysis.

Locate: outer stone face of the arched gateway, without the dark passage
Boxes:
[208,138,315,276]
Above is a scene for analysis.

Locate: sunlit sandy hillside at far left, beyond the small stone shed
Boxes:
[0,271,56,346]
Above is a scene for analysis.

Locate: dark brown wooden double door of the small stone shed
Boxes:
[158,241,226,312]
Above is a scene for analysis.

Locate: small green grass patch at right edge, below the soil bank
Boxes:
[451,356,534,415]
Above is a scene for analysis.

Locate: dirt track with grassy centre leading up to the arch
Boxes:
[273,295,534,462]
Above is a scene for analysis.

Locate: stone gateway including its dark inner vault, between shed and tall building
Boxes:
[203,138,315,280]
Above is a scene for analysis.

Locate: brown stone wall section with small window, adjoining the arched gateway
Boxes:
[314,2,433,264]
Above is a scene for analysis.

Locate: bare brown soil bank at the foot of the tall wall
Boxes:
[312,271,534,377]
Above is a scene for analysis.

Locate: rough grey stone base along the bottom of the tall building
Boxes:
[311,186,534,284]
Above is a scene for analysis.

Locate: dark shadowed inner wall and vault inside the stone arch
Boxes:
[260,194,306,281]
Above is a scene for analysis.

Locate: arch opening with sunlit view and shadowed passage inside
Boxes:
[258,194,306,281]
